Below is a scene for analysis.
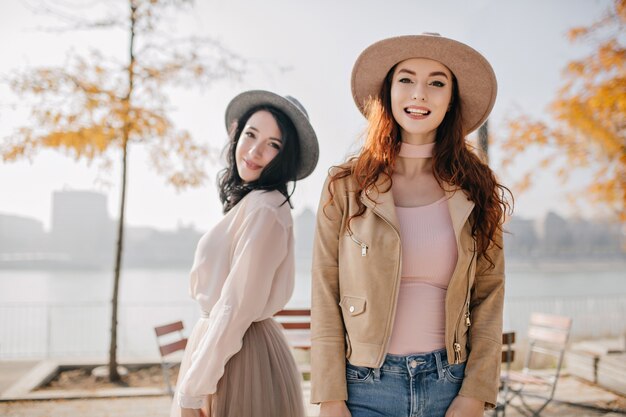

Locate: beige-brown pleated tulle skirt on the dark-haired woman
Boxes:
[170,319,304,417]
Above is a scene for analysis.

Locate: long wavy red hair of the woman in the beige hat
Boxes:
[328,66,513,267]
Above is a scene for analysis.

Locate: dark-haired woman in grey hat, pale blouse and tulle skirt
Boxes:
[171,91,319,417]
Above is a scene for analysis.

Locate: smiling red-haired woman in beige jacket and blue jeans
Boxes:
[311,34,510,417]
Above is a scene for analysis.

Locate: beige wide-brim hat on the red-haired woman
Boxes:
[352,33,498,134]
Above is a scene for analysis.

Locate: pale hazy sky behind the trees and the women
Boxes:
[0,0,612,230]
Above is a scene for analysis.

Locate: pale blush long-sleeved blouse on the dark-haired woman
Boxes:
[177,191,295,408]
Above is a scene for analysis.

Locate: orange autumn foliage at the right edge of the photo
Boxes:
[503,0,626,221]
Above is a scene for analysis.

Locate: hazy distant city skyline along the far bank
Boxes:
[0,191,626,273]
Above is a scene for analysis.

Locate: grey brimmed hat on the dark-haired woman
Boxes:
[225,90,320,180]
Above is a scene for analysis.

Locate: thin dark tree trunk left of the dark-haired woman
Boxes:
[109,0,137,382]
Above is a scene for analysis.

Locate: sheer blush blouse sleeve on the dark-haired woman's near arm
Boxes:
[178,206,289,408]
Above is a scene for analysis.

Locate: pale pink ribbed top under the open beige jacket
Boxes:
[389,197,457,355]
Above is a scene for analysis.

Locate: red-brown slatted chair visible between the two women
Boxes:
[274,309,311,379]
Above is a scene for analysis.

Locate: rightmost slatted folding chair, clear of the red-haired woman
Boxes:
[504,313,572,417]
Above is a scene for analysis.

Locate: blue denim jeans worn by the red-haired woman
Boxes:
[346,349,465,417]
